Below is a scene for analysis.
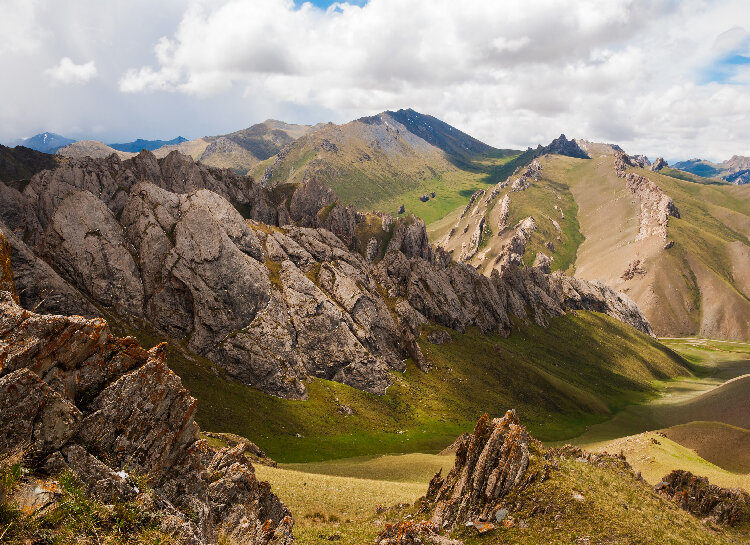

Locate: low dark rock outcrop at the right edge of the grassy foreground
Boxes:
[654,469,750,526]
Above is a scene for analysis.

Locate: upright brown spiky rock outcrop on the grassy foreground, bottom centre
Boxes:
[425,411,541,531]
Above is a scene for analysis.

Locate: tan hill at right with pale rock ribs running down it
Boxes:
[429,141,750,339]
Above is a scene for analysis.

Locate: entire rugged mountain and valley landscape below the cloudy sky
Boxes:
[0,109,750,545]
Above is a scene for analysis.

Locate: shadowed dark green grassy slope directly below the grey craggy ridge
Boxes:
[122,312,689,462]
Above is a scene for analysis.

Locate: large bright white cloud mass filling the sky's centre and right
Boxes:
[113,0,750,159]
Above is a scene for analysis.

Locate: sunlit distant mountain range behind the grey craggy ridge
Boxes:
[5,110,750,339]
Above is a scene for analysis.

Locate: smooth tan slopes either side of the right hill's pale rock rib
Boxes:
[527,154,750,338]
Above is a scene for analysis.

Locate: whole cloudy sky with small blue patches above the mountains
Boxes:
[0,0,750,160]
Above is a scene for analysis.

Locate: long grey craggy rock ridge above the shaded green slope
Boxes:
[0,151,651,399]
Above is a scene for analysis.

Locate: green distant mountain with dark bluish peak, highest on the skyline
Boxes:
[252,110,520,223]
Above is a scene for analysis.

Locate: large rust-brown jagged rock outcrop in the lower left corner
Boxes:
[0,291,293,545]
